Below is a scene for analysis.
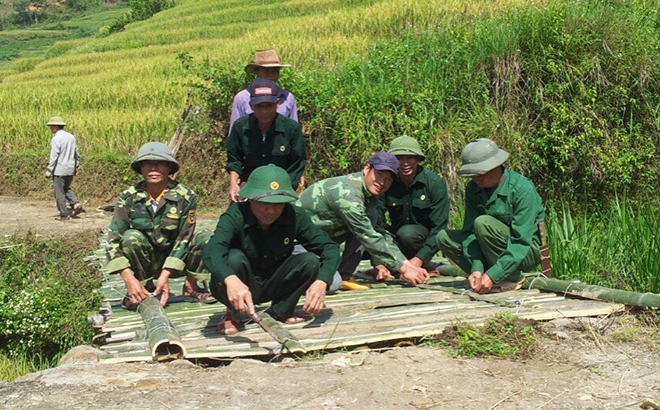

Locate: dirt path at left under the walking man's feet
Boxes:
[0,196,112,236]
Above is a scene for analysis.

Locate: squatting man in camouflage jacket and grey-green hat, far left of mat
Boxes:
[107,142,216,309]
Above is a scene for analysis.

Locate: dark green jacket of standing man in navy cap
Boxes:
[227,114,307,189]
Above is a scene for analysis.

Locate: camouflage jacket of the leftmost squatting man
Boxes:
[108,181,197,273]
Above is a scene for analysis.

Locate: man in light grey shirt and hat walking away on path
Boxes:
[46,117,85,220]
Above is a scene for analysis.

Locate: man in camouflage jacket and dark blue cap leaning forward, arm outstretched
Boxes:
[299,152,429,288]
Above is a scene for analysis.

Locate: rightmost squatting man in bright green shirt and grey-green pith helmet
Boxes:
[437,138,545,293]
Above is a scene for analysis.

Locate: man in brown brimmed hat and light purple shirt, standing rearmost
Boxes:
[229,48,298,130]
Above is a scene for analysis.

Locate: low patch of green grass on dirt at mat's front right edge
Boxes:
[425,313,539,359]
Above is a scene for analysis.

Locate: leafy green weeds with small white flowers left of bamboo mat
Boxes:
[0,231,101,380]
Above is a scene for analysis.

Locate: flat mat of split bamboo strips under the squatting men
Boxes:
[89,227,623,363]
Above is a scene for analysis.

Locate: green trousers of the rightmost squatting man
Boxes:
[436,215,541,282]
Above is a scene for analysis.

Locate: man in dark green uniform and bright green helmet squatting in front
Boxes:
[203,164,339,335]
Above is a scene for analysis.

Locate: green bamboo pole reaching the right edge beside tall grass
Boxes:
[523,276,660,307]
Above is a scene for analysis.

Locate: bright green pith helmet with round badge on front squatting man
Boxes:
[238,164,298,203]
